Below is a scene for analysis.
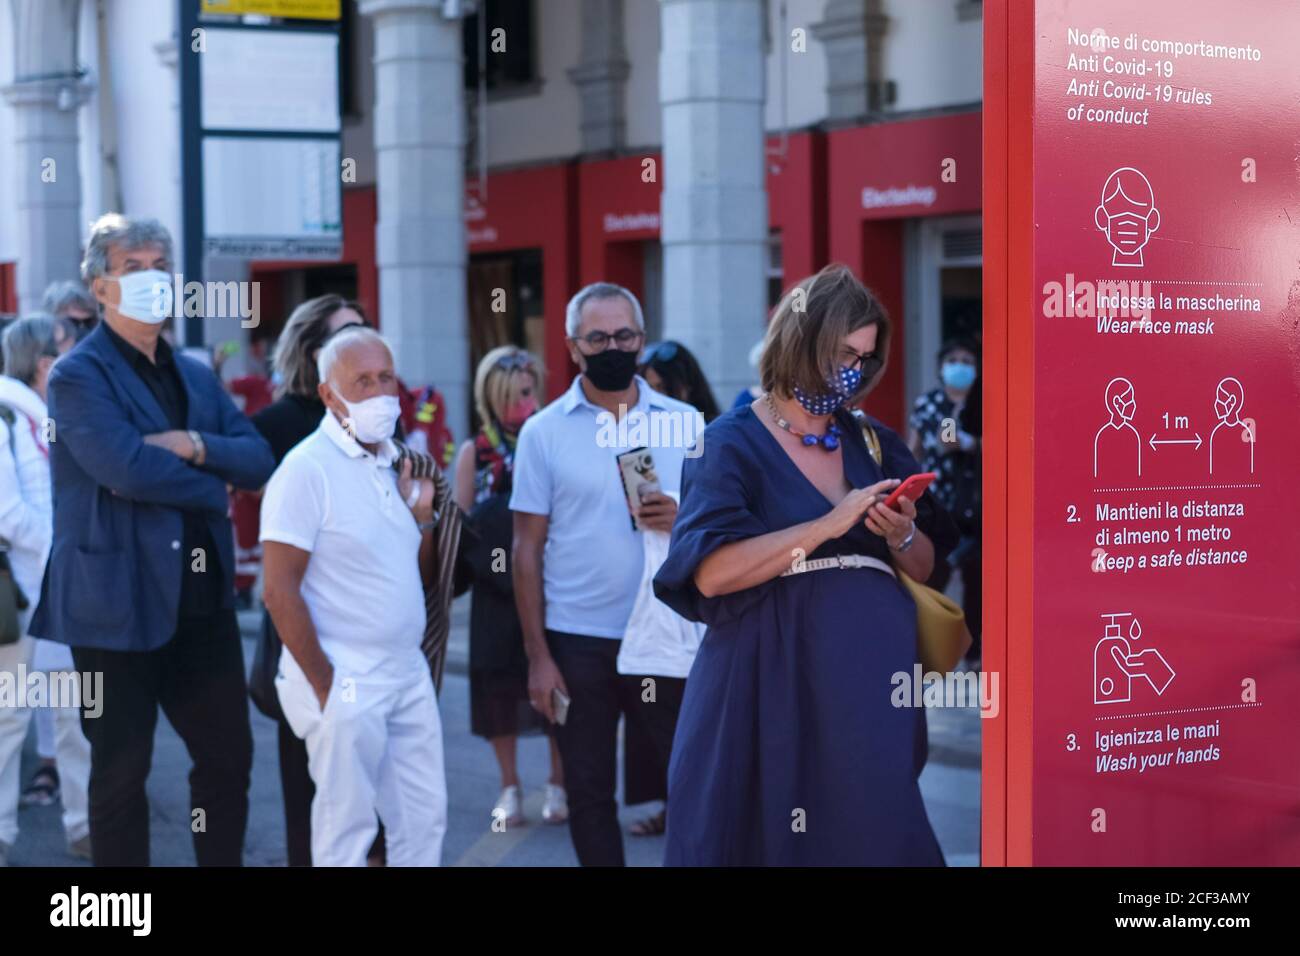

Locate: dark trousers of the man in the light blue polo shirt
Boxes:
[546,631,644,866]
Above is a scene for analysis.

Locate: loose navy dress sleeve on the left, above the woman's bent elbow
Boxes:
[654,415,771,624]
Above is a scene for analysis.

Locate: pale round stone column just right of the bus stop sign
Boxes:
[360,0,471,441]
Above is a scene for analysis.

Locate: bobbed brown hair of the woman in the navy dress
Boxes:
[758,263,889,403]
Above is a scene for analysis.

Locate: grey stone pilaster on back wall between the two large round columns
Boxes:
[568,0,632,153]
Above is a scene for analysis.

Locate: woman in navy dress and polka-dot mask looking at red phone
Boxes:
[655,267,956,866]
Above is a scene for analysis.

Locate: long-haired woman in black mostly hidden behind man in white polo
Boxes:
[250,295,365,866]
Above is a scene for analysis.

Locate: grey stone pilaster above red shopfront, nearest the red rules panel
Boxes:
[813,0,889,122]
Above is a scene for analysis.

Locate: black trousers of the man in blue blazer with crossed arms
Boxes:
[73,610,252,866]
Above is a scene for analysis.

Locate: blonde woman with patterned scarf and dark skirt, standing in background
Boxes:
[455,345,568,827]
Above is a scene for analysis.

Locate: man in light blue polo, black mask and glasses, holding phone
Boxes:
[510,282,699,866]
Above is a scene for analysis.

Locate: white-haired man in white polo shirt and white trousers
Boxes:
[261,328,447,866]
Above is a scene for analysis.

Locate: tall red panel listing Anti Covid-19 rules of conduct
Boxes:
[985,0,1300,865]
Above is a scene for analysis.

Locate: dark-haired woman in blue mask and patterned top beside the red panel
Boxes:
[907,339,983,667]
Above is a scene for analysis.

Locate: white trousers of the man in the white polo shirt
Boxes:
[276,670,447,866]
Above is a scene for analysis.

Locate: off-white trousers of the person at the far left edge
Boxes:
[0,637,90,847]
